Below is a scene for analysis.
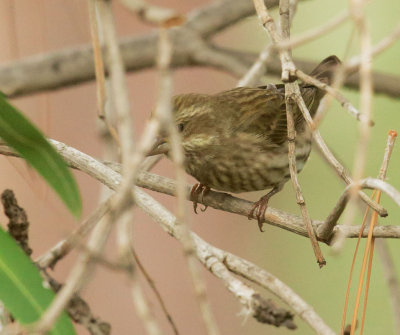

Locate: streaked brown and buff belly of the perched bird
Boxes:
[186,142,311,193]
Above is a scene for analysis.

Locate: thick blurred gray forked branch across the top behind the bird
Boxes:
[0,0,400,97]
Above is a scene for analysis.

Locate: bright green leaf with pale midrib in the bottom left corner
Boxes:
[0,228,75,335]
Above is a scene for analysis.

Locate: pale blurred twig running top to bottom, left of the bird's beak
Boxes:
[99,0,165,335]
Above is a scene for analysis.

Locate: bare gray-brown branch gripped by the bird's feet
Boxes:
[0,140,400,243]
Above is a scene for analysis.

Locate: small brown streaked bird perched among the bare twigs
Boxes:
[148,55,341,231]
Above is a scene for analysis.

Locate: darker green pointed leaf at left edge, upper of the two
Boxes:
[0,95,82,217]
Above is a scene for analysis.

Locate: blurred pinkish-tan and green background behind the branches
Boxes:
[0,0,400,335]
